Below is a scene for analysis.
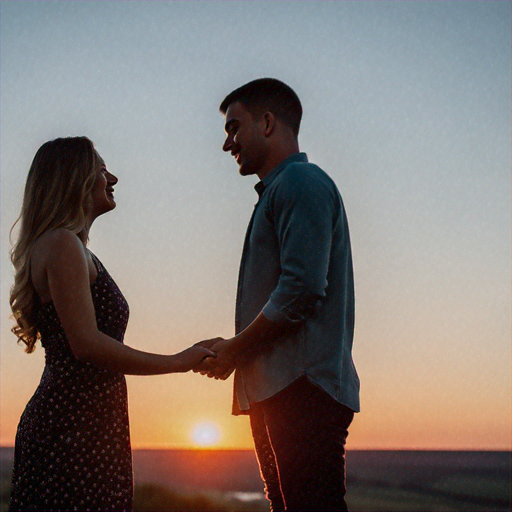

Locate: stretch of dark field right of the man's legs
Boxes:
[347,451,511,512]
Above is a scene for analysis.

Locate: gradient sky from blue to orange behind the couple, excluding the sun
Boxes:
[0,0,511,449]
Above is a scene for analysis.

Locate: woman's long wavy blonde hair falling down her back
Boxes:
[10,137,101,353]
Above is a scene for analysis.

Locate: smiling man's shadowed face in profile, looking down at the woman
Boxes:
[222,101,267,176]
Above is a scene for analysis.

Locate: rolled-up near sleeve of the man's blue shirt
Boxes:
[262,165,337,323]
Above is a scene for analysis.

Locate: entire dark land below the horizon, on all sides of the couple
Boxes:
[0,448,511,512]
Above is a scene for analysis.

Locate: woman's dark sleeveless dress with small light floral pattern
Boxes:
[10,255,133,512]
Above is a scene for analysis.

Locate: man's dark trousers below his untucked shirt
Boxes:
[250,377,354,512]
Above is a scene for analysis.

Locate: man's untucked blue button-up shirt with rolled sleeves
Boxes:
[233,153,359,414]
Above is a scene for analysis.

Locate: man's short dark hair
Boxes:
[219,78,302,137]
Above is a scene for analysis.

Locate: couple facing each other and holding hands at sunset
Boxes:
[10,78,359,512]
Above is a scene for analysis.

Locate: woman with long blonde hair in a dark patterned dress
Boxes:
[10,137,215,512]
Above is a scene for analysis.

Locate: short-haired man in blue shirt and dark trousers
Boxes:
[197,78,359,511]
